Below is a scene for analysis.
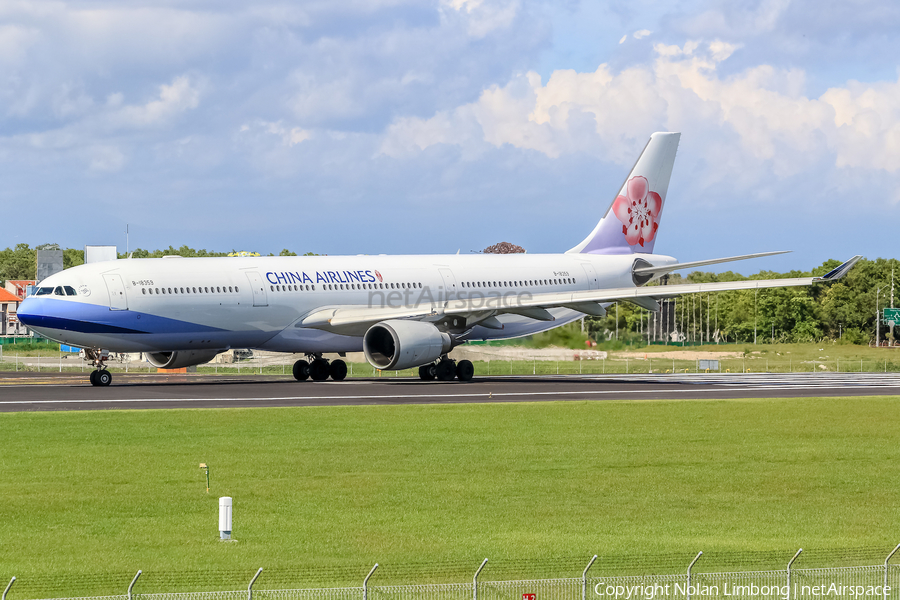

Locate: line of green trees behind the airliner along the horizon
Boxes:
[0,244,900,344]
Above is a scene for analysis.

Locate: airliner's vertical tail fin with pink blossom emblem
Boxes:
[568,132,681,254]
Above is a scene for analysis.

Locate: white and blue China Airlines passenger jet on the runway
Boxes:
[12,132,861,386]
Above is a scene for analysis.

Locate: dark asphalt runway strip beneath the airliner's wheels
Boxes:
[0,373,900,412]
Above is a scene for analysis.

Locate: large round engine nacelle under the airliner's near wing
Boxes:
[363,320,453,371]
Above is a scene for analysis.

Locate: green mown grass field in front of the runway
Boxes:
[0,397,900,600]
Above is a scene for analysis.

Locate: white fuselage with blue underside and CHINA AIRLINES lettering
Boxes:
[19,254,675,353]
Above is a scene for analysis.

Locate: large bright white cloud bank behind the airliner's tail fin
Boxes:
[382,41,900,181]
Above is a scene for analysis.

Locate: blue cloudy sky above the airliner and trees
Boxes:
[0,0,900,272]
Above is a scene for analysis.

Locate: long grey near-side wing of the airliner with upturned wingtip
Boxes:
[297,256,862,334]
